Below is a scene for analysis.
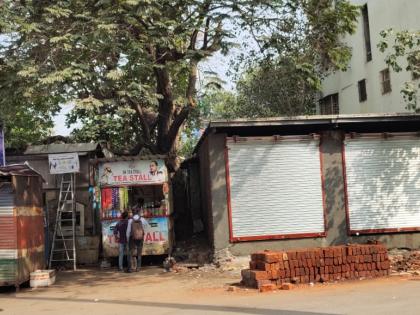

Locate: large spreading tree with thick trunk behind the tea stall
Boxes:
[0,0,357,153]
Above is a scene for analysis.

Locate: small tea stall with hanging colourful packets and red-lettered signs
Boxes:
[93,157,174,258]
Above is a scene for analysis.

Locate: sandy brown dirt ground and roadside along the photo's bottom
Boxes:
[0,267,420,315]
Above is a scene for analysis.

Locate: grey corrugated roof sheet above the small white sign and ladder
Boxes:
[24,143,98,155]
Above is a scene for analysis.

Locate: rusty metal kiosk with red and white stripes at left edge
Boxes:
[0,164,45,286]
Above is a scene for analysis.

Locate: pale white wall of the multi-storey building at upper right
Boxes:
[322,0,420,114]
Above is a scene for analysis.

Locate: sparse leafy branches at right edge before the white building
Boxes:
[378,29,420,112]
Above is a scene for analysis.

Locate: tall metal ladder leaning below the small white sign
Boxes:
[48,174,76,270]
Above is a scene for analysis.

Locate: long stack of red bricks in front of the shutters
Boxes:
[242,244,390,291]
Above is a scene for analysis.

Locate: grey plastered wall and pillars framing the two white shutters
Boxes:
[199,131,420,255]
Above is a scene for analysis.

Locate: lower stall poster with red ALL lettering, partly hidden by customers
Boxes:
[102,218,169,257]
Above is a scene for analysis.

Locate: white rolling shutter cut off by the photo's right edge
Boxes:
[345,137,420,232]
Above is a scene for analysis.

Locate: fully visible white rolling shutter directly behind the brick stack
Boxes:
[228,138,325,241]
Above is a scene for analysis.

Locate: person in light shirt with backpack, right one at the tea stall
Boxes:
[127,210,148,272]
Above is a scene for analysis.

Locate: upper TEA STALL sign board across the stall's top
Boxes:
[98,160,168,186]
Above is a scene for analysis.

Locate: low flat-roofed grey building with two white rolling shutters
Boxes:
[195,114,420,255]
